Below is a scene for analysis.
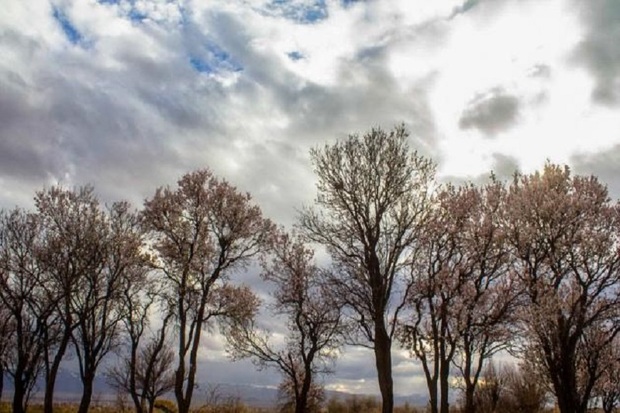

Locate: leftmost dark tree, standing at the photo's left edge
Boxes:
[0,209,48,413]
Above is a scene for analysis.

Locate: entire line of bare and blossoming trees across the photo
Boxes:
[0,126,620,413]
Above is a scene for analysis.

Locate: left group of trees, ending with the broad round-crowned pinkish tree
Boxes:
[0,170,275,413]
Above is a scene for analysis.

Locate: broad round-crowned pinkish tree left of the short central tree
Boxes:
[142,169,273,413]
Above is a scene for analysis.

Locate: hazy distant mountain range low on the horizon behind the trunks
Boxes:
[3,370,428,407]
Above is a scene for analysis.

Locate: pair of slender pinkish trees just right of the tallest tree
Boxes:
[399,180,518,413]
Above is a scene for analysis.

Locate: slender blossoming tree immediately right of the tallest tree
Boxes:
[398,186,470,413]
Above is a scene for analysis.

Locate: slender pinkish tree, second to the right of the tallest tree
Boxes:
[448,177,520,413]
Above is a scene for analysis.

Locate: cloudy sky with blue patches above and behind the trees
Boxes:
[0,0,620,400]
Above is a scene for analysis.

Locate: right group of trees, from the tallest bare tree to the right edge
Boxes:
[299,127,620,413]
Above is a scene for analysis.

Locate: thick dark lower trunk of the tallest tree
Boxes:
[374,318,394,413]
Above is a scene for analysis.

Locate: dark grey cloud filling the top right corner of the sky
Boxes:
[573,0,620,105]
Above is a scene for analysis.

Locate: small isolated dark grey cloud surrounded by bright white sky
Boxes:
[459,88,520,136]
